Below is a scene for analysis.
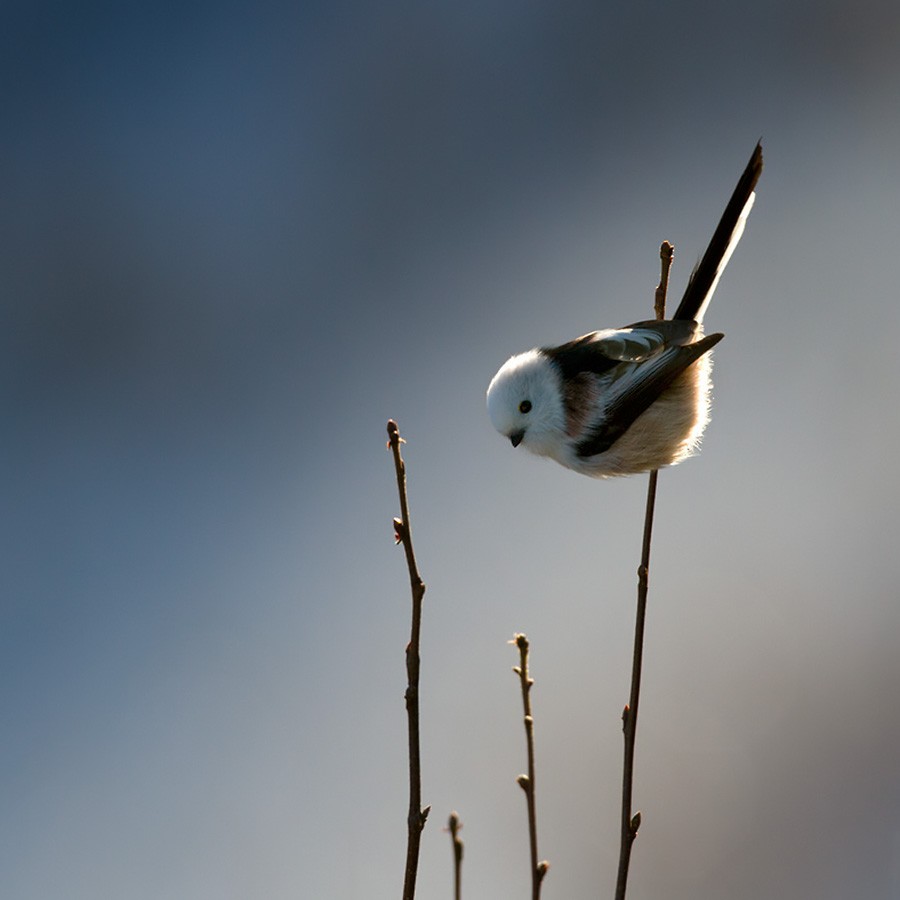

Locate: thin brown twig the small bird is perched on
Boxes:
[616,241,675,900]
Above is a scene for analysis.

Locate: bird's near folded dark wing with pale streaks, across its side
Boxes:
[576,334,724,457]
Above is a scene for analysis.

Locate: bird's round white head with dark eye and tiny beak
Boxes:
[487,350,566,457]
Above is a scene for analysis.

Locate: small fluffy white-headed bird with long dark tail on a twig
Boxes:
[487,143,763,478]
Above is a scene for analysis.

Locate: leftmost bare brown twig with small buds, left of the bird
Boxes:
[387,419,431,900]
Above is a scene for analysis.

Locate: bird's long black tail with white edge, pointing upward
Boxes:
[672,144,762,322]
